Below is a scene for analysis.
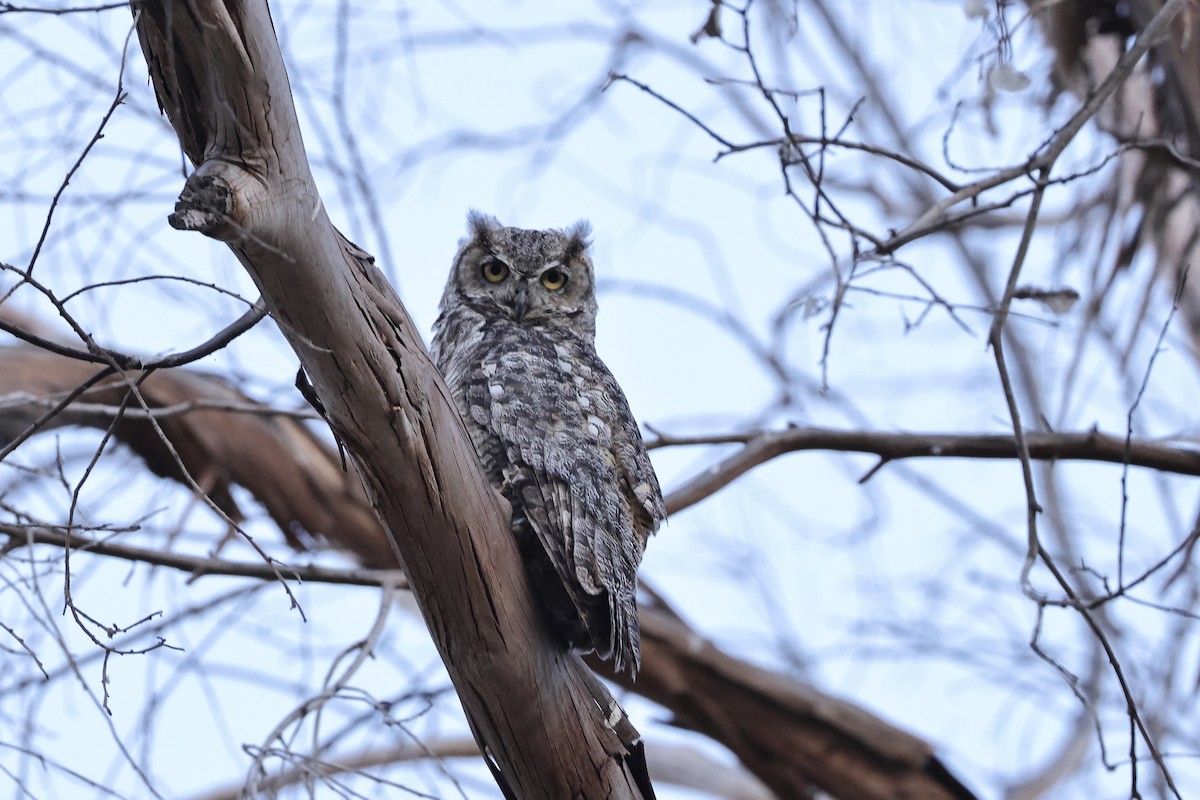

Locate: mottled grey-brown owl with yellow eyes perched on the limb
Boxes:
[432,211,666,674]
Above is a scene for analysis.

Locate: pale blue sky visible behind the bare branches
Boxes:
[0,0,1198,800]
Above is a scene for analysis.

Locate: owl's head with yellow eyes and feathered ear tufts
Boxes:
[442,211,596,339]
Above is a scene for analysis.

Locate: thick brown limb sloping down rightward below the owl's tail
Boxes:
[589,608,974,800]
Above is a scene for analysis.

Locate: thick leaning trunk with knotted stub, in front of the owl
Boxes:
[136,0,652,800]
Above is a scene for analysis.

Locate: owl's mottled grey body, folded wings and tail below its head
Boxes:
[434,309,666,673]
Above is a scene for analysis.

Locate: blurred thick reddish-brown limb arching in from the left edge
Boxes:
[0,344,391,563]
